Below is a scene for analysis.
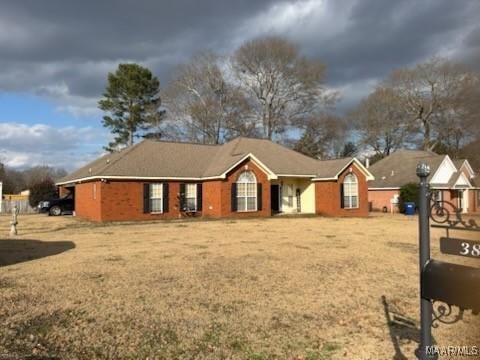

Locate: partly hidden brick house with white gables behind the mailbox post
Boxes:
[368,150,480,213]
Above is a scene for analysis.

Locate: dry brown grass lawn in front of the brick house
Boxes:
[0,215,480,359]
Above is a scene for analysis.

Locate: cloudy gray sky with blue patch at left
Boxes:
[0,0,480,170]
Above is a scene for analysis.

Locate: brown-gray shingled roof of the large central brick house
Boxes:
[58,137,364,183]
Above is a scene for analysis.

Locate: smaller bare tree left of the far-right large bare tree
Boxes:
[350,87,411,157]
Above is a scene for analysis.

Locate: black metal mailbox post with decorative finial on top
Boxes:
[417,163,437,360]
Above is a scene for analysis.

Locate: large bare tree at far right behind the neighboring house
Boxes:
[386,58,478,150]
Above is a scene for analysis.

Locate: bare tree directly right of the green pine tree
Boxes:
[165,52,247,144]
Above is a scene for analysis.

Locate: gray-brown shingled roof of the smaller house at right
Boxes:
[368,150,445,188]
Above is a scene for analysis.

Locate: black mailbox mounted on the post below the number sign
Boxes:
[422,260,480,312]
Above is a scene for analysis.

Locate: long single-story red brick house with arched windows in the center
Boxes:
[57,137,373,221]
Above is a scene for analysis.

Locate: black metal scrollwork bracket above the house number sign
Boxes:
[430,200,480,231]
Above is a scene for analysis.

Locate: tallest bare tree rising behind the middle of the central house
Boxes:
[232,37,334,139]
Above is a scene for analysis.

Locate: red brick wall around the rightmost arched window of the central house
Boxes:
[315,164,368,216]
